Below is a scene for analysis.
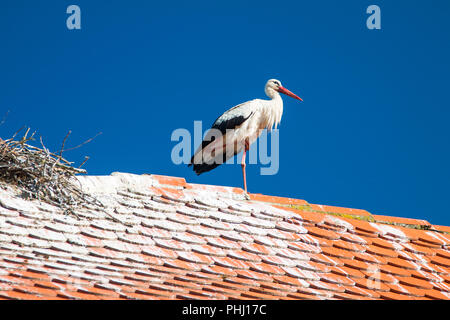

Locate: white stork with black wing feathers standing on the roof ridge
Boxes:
[189,79,303,194]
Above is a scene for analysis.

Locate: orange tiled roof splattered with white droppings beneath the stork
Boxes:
[0,173,450,299]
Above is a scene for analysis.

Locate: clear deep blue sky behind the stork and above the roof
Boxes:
[0,0,450,225]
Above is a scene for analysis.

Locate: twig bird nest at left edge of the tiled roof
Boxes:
[0,129,99,212]
